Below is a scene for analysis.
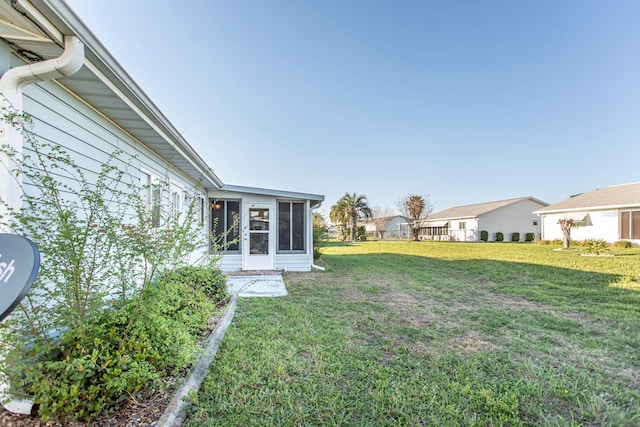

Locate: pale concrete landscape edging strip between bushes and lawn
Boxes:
[156,295,238,427]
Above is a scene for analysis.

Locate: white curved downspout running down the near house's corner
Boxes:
[0,36,84,414]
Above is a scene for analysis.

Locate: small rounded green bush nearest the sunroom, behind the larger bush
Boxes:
[162,266,229,304]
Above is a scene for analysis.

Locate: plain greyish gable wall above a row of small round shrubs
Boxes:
[478,199,544,241]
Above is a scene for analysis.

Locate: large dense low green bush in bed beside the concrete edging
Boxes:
[18,280,214,421]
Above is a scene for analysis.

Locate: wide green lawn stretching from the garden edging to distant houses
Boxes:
[186,242,640,426]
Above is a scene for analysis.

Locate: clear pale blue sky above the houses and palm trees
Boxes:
[67,0,640,217]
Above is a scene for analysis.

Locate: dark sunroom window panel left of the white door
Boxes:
[211,200,240,252]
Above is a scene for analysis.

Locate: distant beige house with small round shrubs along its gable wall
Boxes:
[420,197,548,242]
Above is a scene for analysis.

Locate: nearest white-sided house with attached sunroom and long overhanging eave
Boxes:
[0,0,324,271]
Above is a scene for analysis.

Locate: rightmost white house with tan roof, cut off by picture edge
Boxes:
[535,182,640,243]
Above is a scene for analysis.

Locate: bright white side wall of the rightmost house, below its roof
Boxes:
[541,209,620,242]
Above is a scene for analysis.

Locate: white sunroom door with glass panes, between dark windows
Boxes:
[242,203,275,270]
